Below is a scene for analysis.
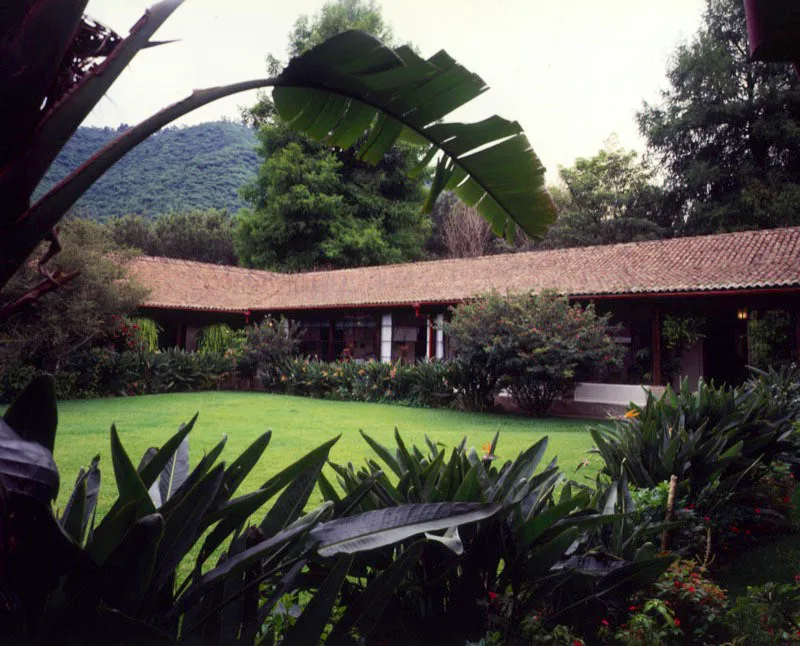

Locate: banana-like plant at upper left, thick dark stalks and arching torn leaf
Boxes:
[0,0,555,306]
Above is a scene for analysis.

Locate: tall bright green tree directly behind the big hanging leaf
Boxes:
[236,0,431,271]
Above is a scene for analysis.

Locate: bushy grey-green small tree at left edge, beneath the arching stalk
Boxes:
[0,219,146,384]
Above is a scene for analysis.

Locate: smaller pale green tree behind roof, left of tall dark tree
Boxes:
[539,137,670,248]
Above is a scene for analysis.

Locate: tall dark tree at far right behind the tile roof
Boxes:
[638,0,800,234]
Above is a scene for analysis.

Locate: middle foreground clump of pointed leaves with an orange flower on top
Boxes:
[320,432,671,644]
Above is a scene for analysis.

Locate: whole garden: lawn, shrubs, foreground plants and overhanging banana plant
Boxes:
[0,0,800,646]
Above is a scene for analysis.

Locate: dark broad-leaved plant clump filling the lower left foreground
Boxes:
[0,377,498,644]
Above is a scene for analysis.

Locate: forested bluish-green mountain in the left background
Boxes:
[39,121,259,220]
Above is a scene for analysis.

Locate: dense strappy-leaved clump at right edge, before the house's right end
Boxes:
[591,369,800,506]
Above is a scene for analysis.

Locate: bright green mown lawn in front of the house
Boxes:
[55,392,598,513]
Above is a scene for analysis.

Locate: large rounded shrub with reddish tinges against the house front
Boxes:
[447,293,624,415]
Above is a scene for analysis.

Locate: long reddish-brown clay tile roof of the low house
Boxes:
[123,228,800,312]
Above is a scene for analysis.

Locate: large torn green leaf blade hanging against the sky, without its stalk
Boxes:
[273,31,555,236]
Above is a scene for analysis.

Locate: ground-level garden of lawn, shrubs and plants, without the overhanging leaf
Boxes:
[0,293,800,646]
